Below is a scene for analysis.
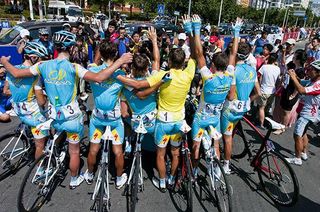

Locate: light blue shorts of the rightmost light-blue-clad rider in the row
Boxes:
[221,109,245,135]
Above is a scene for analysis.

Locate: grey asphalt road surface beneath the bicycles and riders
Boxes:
[0,40,320,212]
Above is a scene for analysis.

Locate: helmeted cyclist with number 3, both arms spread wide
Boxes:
[1,31,132,189]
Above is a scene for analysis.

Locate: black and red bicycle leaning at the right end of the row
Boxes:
[232,117,299,207]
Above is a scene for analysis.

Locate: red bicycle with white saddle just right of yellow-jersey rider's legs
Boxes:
[167,122,195,211]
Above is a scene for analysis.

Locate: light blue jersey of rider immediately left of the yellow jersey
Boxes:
[123,77,157,115]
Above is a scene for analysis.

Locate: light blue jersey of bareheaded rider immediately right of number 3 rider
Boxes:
[89,63,125,111]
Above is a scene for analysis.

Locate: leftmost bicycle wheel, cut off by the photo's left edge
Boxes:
[0,132,28,181]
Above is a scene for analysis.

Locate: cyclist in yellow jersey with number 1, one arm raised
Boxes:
[116,16,196,192]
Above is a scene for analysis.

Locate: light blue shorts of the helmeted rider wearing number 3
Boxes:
[52,114,83,144]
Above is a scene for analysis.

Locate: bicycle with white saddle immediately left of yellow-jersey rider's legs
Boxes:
[124,115,147,211]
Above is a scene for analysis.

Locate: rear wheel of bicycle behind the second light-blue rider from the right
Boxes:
[210,158,232,212]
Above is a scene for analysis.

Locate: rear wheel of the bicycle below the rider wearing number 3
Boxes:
[18,154,59,211]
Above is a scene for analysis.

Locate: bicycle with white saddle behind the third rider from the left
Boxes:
[91,126,114,212]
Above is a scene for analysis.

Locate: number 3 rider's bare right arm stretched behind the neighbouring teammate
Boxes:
[83,53,132,83]
